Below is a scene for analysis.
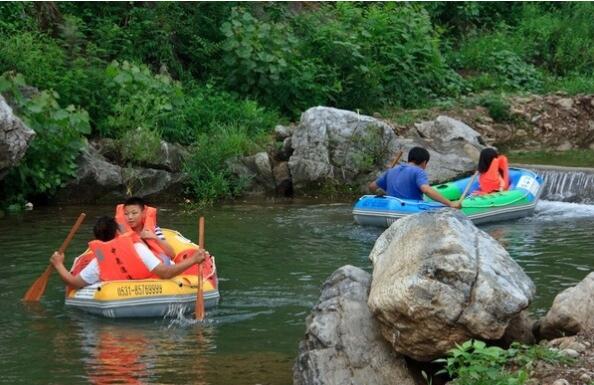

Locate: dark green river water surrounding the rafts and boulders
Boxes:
[0,201,594,385]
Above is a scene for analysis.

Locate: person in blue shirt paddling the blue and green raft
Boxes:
[369,147,460,209]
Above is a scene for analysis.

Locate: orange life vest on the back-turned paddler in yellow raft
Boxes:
[89,231,158,281]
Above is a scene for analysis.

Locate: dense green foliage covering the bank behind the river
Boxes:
[0,2,594,207]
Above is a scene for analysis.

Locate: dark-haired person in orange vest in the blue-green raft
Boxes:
[476,148,509,194]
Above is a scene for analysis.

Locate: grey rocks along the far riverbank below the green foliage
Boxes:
[0,95,594,203]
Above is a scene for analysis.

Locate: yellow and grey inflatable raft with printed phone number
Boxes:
[65,229,219,318]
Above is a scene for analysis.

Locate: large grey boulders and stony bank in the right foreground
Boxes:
[293,209,594,385]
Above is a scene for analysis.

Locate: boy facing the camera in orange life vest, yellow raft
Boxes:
[116,197,175,259]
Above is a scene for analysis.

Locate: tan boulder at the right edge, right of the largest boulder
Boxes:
[539,272,594,339]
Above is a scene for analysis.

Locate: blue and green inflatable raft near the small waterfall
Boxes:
[353,168,543,227]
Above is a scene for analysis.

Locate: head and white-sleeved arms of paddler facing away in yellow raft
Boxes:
[50,217,209,289]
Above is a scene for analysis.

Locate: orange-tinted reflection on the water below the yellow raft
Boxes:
[77,317,214,385]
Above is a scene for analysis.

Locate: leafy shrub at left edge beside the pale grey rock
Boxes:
[0,73,90,200]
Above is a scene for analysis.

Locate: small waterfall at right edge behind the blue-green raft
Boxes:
[526,165,594,204]
